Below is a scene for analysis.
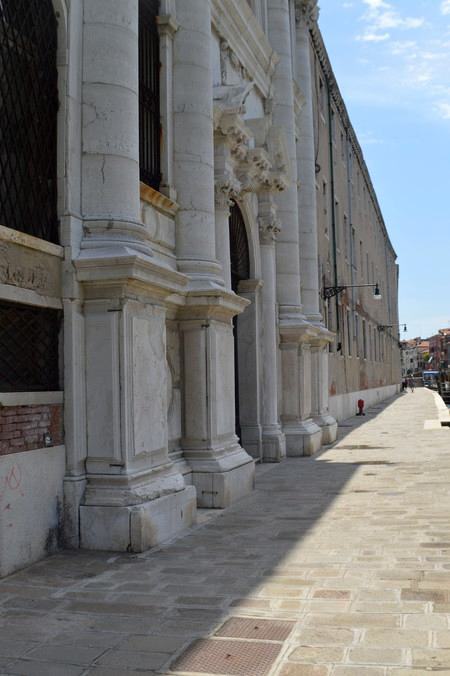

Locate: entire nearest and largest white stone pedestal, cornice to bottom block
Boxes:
[75,256,196,551]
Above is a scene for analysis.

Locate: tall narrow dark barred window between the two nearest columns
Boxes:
[139,0,161,190]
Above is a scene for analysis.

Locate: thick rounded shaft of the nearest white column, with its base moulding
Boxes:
[81,0,151,255]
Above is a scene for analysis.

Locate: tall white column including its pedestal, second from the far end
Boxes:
[268,0,321,455]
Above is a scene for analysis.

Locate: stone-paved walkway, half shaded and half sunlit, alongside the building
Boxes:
[0,390,450,676]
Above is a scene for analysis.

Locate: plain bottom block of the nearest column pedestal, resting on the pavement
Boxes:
[80,486,197,552]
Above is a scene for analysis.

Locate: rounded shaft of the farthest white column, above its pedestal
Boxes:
[295,0,322,322]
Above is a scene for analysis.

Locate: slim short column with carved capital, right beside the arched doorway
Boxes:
[259,214,286,462]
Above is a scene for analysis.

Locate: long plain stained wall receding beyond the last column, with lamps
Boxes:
[311,30,400,419]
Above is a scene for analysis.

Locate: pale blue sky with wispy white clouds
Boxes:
[319,0,450,338]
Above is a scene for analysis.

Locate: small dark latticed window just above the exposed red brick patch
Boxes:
[0,302,62,392]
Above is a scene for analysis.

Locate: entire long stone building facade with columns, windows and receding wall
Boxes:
[0,0,399,575]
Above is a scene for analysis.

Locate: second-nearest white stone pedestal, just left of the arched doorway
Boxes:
[178,289,254,508]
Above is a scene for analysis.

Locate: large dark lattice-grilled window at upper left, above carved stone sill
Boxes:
[0,0,58,242]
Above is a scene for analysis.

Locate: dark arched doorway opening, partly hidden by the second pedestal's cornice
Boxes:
[229,202,250,440]
